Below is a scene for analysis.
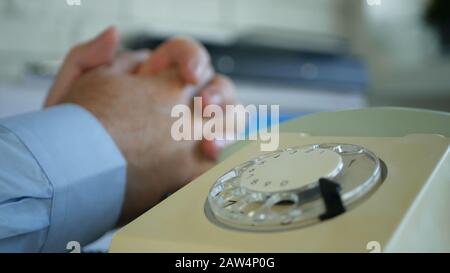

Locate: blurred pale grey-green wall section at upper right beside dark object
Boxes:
[349,0,450,111]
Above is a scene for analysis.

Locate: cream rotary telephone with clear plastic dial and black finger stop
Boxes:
[111,107,450,252]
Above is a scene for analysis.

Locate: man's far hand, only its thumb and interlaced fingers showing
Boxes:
[44,27,236,160]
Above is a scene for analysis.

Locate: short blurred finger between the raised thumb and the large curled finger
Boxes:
[110,49,151,74]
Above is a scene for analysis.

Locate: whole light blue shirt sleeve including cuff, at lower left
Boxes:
[0,105,126,252]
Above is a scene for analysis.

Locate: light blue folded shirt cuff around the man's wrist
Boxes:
[0,105,126,252]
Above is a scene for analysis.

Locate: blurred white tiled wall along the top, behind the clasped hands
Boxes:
[0,0,352,78]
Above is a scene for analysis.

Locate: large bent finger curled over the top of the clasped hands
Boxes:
[140,37,211,84]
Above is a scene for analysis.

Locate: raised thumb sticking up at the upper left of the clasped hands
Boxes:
[45,27,119,107]
